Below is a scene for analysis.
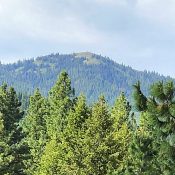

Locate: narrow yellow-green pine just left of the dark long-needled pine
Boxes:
[111,93,135,174]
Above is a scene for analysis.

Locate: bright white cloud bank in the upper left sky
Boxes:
[0,0,105,44]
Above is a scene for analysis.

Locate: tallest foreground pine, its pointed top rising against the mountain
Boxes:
[37,71,75,175]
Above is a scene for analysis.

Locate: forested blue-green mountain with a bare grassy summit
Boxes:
[0,52,171,103]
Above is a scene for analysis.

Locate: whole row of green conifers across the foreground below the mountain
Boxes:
[0,72,175,175]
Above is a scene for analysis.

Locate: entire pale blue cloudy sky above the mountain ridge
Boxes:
[0,0,175,77]
